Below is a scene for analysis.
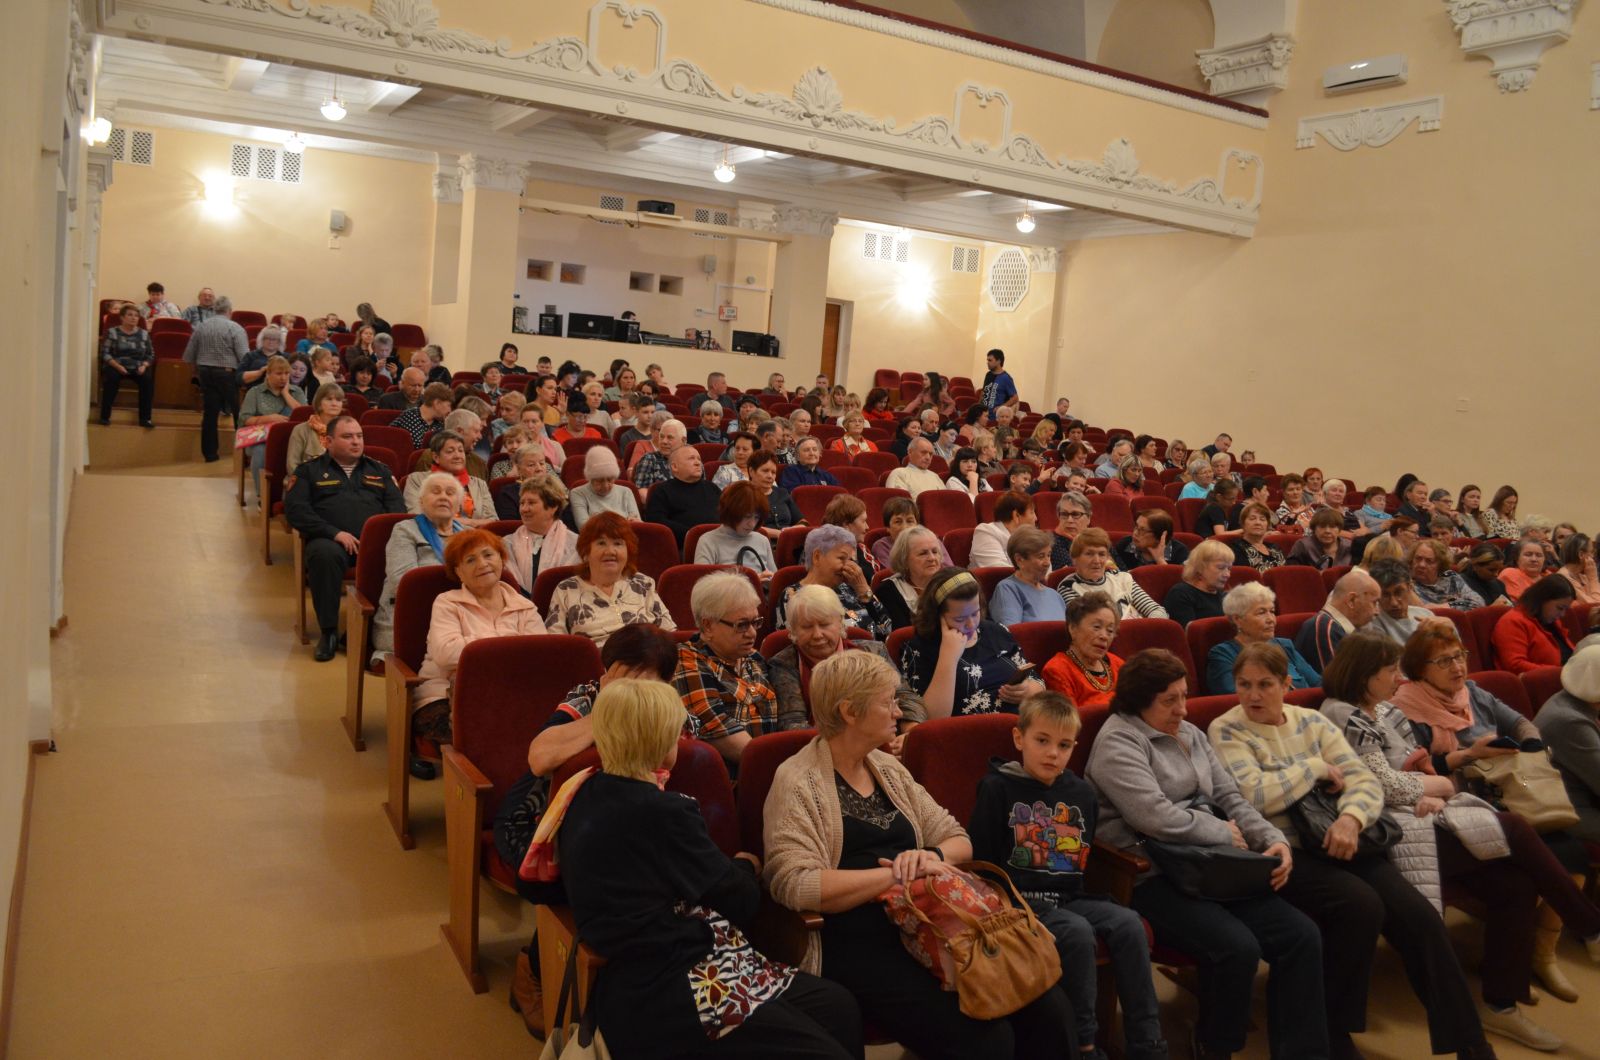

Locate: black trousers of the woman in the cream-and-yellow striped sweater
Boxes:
[1278,850,1483,1054]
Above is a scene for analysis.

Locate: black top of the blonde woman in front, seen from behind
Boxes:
[563,773,761,1057]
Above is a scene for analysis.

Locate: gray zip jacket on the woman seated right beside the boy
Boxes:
[1083,714,1286,873]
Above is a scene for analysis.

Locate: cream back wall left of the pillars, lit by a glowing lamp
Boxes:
[99,128,438,323]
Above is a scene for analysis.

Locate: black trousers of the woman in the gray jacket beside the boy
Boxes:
[1131,877,1328,1060]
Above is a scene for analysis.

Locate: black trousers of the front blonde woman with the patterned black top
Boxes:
[682,972,862,1060]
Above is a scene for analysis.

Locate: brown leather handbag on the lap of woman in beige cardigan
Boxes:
[890,861,1061,1020]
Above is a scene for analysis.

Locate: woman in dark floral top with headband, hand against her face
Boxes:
[901,567,1045,717]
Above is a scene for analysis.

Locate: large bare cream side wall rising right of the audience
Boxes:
[1058,0,1600,528]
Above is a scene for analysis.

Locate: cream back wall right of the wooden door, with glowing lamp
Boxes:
[827,226,981,395]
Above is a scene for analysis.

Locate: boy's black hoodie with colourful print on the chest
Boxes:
[966,759,1099,897]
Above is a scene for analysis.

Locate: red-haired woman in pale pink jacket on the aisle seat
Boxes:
[411,528,546,758]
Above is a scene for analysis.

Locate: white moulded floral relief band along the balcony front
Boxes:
[187,0,1264,235]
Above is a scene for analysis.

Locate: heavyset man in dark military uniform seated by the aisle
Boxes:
[283,416,405,663]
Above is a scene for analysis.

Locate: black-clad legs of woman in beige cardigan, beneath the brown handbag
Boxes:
[822,917,1078,1060]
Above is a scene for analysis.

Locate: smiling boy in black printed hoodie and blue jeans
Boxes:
[966,692,1166,1060]
